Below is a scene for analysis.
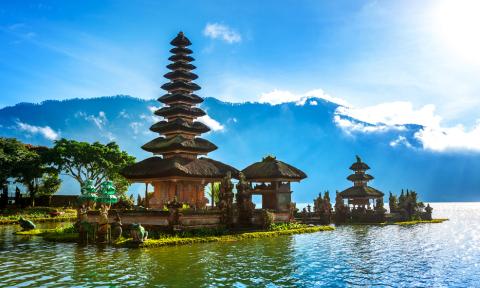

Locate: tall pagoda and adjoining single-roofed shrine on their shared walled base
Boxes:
[75,32,307,241]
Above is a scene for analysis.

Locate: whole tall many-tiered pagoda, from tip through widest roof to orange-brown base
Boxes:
[122,32,238,208]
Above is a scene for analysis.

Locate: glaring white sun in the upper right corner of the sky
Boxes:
[433,0,480,64]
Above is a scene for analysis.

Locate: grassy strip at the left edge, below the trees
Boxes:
[0,207,77,225]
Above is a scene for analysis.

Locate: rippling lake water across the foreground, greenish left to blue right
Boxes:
[0,203,480,287]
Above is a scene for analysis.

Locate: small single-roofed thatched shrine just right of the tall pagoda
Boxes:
[242,156,307,212]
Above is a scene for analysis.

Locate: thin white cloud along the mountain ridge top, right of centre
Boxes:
[258,89,350,106]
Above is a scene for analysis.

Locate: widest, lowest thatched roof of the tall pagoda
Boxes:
[121,156,238,181]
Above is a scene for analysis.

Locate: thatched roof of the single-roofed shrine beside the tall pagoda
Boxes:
[242,156,307,182]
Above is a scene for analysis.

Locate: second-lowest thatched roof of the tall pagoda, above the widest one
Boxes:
[142,135,217,154]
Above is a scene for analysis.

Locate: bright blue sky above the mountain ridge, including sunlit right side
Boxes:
[0,0,480,152]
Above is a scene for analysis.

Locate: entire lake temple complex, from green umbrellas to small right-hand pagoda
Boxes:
[11,32,444,245]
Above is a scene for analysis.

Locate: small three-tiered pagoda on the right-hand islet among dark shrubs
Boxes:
[340,156,383,208]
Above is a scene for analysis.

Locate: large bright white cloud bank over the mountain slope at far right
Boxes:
[334,102,480,152]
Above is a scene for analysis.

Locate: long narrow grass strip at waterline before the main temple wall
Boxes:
[114,226,335,248]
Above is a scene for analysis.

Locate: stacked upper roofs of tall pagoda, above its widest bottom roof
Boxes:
[142,32,217,159]
